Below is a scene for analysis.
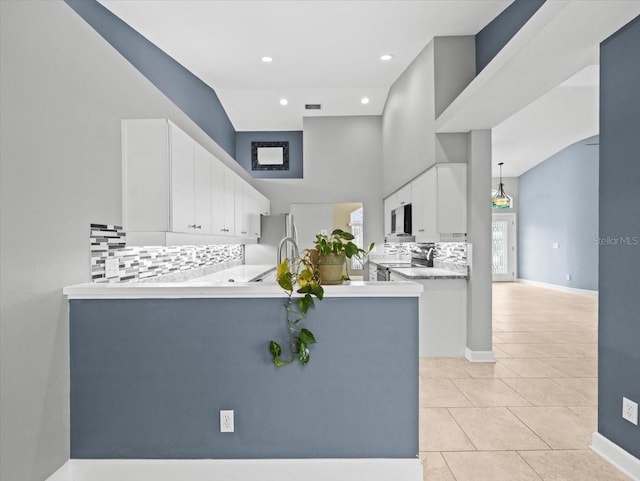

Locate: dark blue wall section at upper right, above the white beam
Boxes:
[476,0,545,74]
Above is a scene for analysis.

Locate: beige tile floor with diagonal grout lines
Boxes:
[420,283,629,481]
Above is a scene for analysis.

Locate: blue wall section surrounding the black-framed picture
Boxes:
[236,130,304,179]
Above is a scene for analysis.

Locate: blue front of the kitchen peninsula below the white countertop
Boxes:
[69,298,419,459]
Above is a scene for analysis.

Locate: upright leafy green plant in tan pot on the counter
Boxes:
[312,229,375,285]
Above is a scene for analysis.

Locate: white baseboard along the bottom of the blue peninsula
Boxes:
[47,458,423,481]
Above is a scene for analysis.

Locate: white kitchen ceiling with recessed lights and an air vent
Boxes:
[100,0,511,131]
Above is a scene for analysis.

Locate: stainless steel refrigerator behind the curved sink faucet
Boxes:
[244,214,298,265]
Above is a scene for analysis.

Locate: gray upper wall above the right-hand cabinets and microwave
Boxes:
[382,36,475,197]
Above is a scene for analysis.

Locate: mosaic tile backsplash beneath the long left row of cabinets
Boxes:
[90,224,244,283]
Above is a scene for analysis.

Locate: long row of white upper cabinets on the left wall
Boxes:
[122,119,270,245]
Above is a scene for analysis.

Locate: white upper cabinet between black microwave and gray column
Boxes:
[411,164,467,242]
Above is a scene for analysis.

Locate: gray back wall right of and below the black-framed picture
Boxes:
[255,116,384,246]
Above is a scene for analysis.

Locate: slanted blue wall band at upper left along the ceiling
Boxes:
[65,0,236,157]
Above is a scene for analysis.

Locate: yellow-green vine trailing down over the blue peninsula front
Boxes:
[269,249,324,367]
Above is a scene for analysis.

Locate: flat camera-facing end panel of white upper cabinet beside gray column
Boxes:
[437,164,467,234]
